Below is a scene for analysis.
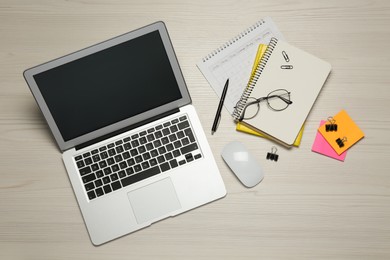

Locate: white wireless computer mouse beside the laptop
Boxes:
[221,141,264,188]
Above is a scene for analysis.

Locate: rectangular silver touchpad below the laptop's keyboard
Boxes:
[127,178,181,224]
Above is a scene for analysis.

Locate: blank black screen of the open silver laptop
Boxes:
[34,31,182,141]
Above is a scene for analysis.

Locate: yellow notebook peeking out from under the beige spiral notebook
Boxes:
[236,44,304,147]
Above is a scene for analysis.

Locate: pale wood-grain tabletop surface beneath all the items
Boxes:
[0,0,390,259]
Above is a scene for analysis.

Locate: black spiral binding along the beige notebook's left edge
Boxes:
[232,37,278,121]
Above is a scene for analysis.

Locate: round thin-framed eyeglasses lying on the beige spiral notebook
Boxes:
[238,89,292,121]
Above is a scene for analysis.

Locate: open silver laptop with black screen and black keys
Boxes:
[24,22,226,245]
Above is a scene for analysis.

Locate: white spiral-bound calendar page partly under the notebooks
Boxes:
[197,17,284,114]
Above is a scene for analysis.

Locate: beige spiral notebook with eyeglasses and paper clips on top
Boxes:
[233,38,331,146]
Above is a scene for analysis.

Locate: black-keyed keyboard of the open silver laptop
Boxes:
[75,115,202,200]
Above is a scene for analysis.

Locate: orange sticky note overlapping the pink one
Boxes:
[318,110,364,155]
